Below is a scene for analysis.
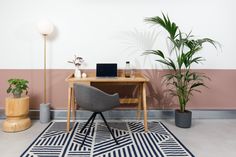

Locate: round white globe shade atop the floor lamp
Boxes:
[37,20,54,35]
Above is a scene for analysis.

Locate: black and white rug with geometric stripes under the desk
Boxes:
[21,121,194,157]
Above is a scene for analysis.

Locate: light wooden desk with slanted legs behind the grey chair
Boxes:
[65,74,148,131]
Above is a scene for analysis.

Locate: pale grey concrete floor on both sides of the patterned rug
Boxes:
[0,119,236,157]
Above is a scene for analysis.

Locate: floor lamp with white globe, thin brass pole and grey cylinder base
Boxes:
[38,20,54,123]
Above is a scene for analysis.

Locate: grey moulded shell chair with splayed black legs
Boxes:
[74,84,120,148]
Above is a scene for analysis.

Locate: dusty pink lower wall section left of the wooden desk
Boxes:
[0,69,73,109]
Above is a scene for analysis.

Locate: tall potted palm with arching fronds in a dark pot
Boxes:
[144,13,218,128]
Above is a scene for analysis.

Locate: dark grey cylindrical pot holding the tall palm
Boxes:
[175,110,192,128]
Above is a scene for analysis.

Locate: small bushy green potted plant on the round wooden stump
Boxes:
[7,79,29,98]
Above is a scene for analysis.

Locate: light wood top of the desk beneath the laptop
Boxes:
[65,74,148,82]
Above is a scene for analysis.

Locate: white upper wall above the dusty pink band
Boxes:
[0,0,236,69]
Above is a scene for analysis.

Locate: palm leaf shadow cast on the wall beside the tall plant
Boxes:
[120,29,173,109]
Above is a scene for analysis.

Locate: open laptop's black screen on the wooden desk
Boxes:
[96,63,117,77]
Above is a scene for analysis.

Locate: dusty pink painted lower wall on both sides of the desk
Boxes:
[0,69,236,109]
